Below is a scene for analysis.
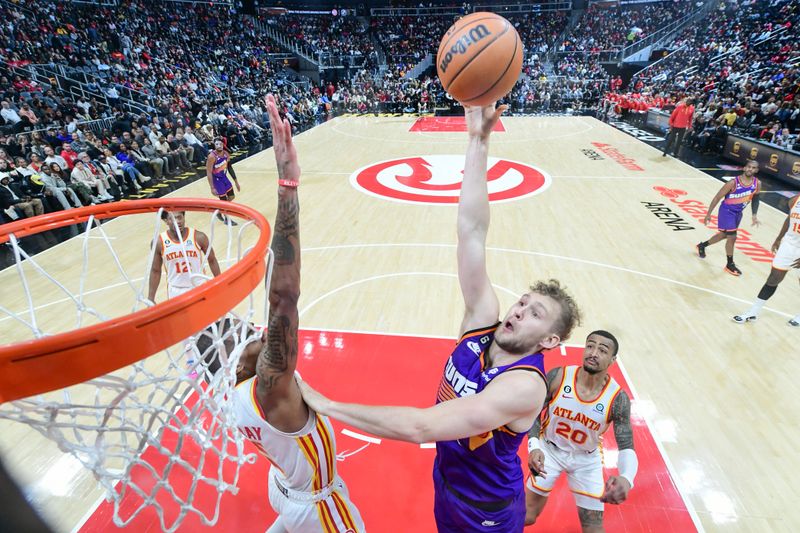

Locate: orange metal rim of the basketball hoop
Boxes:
[0,198,271,403]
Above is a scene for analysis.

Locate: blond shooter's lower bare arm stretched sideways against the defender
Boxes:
[298,372,547,444]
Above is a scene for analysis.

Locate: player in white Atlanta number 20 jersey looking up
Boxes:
[525,330,639,533]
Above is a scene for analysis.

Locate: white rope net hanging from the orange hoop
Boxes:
[0,207,271,531]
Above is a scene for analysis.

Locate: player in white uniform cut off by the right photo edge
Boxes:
[733,195,800,327]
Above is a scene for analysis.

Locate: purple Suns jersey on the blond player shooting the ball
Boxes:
[436,323,546,502]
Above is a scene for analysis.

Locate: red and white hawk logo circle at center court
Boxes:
[350,155,552,204]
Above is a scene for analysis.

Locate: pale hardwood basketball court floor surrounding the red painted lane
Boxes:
[0,117,800,532]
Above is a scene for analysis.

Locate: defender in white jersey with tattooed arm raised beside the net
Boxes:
[228,95,364,533]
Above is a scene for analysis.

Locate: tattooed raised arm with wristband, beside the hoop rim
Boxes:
[256,95,302,409]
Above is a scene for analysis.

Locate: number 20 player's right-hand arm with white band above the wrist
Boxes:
[601,391,639,504]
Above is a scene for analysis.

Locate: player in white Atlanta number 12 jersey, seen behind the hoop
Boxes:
[147,211,220,302]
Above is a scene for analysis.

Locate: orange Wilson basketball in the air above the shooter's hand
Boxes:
[436,12,523,106]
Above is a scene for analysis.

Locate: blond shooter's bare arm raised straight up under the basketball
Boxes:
[457,104,507,334]
